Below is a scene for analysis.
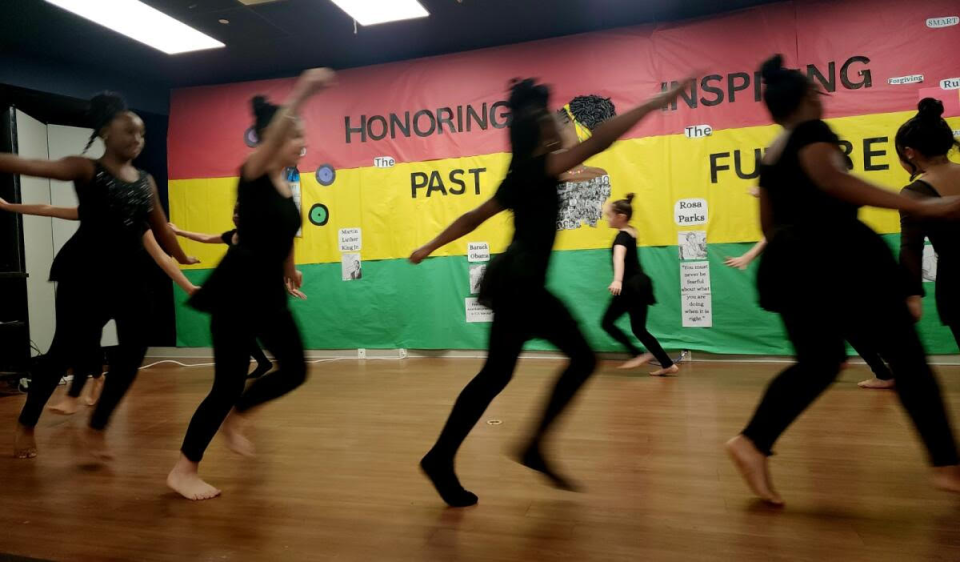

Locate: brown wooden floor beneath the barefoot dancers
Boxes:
[0,359,960,562]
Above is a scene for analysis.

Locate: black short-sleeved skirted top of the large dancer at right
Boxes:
[757,120,903,313]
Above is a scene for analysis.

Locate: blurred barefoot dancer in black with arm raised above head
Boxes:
[167,69,334,500]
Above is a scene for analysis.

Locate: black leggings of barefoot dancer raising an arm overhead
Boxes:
[177,308,307,462]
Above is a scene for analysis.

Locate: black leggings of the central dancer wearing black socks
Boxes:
[431,289,597,460]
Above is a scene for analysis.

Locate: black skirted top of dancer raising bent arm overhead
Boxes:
[190,169,300,312]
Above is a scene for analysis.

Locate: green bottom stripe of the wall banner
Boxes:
[176,234,957,355]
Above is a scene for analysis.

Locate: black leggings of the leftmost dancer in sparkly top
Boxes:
[19,279,150,430]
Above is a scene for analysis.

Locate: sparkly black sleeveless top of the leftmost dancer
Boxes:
[50,162,154,281]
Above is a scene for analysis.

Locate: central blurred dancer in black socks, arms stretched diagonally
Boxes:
[410,76,681,507]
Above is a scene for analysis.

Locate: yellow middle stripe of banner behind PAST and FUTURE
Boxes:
[170,112,960,268]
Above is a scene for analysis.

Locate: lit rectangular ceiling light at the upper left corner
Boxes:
[47,0,225,55]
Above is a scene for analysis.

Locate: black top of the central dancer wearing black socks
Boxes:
[478,155,560,307]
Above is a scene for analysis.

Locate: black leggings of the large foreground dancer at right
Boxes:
[743,302,957,466]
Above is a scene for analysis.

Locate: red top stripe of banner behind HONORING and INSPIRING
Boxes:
[168,0,960,179]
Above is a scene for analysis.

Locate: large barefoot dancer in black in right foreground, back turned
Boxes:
[727,55,960,505]
